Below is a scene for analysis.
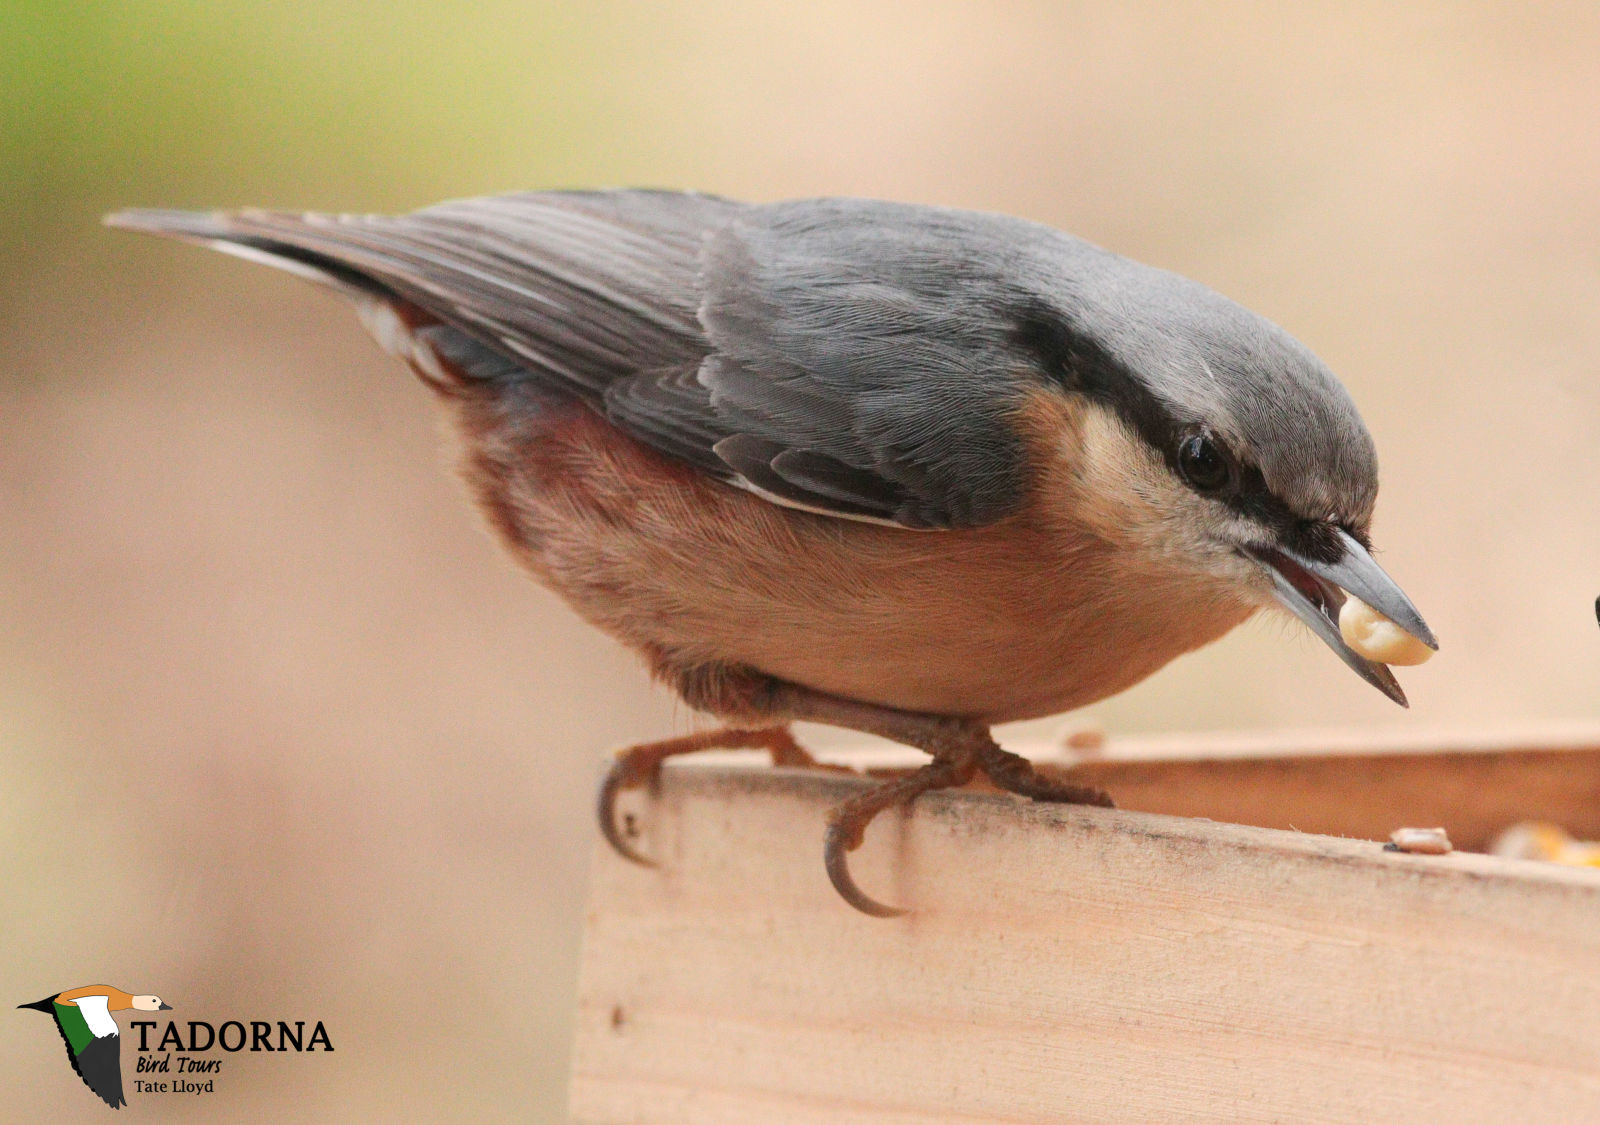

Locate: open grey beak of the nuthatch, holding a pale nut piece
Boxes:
[1250,530,1438,707]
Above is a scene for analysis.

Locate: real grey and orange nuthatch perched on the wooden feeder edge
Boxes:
[107,189,1438,917]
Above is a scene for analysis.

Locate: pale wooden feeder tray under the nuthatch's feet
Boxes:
[571,730,1600,1125]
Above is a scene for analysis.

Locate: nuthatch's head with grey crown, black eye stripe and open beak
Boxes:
[1021,264,1438,706]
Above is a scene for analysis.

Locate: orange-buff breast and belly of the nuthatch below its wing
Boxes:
[444,387,1251,722]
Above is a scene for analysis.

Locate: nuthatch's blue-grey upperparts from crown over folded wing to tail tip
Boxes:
[106,192,1376,528]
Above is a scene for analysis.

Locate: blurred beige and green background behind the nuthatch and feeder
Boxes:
[0,0,1600,1122]
